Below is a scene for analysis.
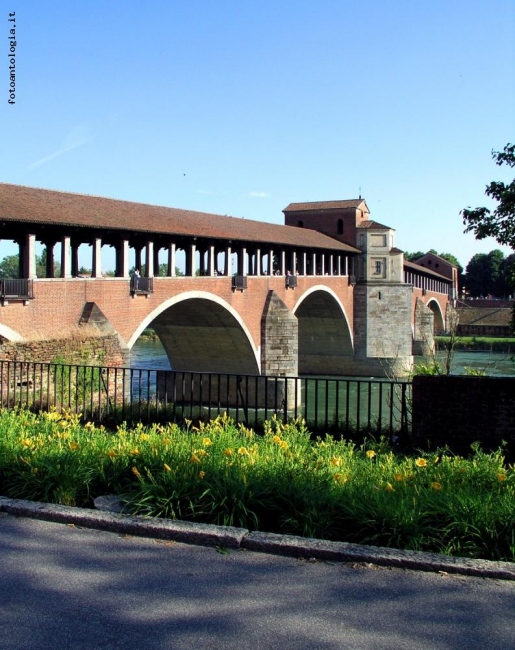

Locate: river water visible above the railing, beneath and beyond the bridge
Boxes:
[130,338,515,377]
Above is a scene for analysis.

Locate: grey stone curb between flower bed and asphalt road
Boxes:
[0,497,515,580]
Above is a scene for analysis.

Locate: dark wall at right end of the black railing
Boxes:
[412,375,515,462]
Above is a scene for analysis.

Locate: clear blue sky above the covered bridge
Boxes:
[0,0,515,266]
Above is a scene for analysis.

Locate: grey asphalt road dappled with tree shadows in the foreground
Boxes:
[0,513,515,650]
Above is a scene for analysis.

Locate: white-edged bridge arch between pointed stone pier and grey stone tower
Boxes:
[293,285,354,375]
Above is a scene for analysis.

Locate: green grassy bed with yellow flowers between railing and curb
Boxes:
[0,410,515,562]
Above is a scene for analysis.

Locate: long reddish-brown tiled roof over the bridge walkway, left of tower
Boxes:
[0,183,360,253]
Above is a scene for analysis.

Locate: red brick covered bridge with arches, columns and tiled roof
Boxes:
[0,184,456,376]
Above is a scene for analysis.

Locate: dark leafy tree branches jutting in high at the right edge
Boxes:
[461,144,515,248]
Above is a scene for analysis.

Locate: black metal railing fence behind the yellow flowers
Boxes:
[0,361,411,436]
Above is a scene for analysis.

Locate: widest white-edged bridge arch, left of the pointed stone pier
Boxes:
[128,291,260,375]
